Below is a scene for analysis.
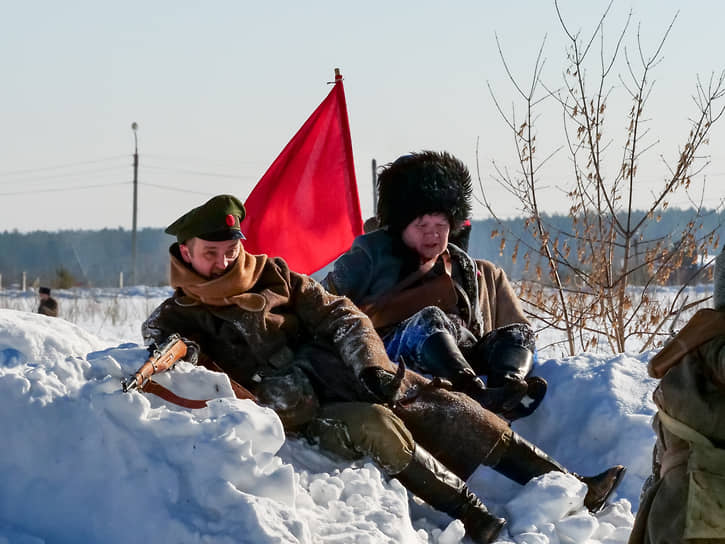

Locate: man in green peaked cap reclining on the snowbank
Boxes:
[143,195,624,543]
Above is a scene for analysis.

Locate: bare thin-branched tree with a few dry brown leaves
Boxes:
[478,1,725,355]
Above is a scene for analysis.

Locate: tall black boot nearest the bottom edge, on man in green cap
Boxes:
[393,445,506,544]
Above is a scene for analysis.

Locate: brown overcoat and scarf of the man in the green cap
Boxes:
[143,246,508,479]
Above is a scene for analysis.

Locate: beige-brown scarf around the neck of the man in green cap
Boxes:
[170,251,267,312]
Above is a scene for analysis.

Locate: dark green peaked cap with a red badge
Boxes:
[164,195,246,243]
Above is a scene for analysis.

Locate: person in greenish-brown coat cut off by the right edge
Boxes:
[629,252,725,544]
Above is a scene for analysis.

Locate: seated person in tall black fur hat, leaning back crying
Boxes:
[322,151,546,420]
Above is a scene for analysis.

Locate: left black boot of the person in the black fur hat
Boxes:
[421,332,527,413]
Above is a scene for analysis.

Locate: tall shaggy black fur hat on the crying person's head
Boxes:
[377,151,473,234]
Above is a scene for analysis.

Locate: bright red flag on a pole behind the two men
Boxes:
[242,70,363,274]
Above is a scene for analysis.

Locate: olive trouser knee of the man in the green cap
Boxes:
[349,404,415,474]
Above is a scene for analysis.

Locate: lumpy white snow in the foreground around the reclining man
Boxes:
[0,288,656,544]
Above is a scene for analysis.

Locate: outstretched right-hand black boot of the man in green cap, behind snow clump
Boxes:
[491,432,626,512]
